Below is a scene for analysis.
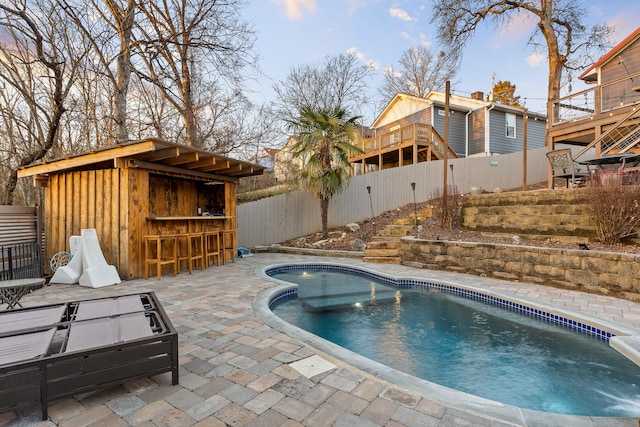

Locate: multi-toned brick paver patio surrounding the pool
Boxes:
[0,254,640,427]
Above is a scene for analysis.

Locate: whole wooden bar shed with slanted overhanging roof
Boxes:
[18,139,264,280]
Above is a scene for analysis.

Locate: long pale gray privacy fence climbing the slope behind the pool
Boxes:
[238,148,547,248]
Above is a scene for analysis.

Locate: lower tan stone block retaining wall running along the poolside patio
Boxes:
[400,237,640,301]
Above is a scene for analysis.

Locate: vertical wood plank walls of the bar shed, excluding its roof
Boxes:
[44,168,236,280]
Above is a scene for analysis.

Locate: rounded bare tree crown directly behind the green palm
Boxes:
[274,54,373,120]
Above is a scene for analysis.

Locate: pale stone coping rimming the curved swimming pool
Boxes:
[252,262,640,426]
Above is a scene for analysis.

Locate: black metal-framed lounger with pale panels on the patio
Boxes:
[0,292,178,420]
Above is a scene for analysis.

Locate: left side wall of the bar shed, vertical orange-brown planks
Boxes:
[44,169,141,279]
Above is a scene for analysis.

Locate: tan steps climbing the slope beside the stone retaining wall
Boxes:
[362,208,431,264]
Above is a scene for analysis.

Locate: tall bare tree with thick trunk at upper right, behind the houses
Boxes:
[432,0,613,125]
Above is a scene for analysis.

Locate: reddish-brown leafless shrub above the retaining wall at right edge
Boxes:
[586,173,640,245]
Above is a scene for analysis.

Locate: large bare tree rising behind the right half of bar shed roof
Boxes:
[135,0,254,147]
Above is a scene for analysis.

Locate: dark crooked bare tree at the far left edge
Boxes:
[0,0,86,204]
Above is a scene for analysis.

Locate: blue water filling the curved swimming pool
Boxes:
[269,270,640,417]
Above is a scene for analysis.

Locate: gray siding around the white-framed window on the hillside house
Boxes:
[489,110,545,154]
